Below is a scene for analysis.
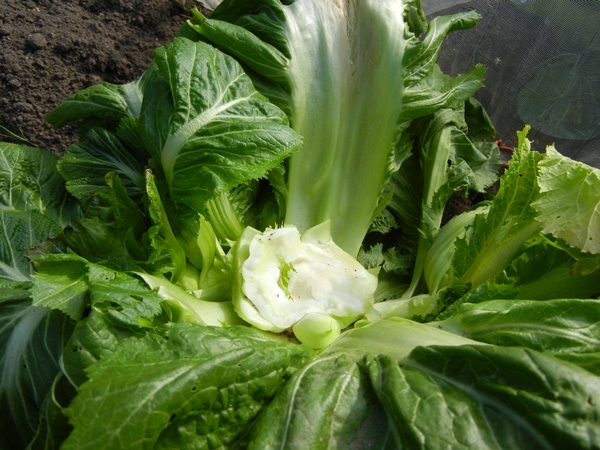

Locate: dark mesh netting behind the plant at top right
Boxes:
[422,0,600,167]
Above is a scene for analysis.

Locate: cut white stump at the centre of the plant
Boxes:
[234,222,377,345]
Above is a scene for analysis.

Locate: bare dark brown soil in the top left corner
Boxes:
[0,0,202,154]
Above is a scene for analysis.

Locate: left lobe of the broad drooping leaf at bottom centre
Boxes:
[247,355,394,449]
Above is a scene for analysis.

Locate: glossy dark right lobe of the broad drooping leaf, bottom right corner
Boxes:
[369,345,600,450]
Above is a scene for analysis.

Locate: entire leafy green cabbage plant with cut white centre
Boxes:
[0,0,600,449]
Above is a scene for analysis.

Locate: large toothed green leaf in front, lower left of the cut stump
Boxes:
[63,324,309,450]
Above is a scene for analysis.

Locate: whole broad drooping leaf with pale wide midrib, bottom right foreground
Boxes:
[251,316,600,449]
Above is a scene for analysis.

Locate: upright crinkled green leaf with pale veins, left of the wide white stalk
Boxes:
[140,38,301,212]
